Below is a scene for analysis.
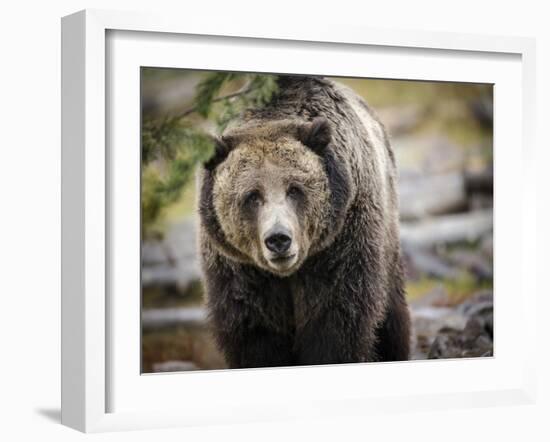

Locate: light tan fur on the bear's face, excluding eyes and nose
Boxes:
[213,131,330,276]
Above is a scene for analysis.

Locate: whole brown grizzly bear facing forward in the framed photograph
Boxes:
[199,76,410,368]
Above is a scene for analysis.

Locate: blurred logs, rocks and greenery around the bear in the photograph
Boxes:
[141,68,493,373]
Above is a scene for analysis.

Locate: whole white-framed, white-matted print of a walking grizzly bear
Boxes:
[62,11,536,431]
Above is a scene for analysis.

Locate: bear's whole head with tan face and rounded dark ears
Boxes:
[199,118,349,276]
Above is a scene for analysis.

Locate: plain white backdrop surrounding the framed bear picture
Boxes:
[0,0,550,441]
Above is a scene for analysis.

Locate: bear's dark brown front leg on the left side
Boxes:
[206,258,294,368]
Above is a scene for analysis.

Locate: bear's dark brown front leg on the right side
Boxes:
[294,252,386,365]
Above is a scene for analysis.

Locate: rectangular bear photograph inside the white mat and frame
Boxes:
[140,66,494,374]
